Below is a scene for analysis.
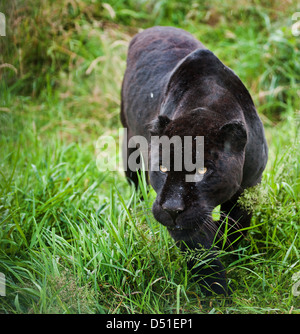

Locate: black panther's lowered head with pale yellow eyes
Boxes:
[150,108,247,248]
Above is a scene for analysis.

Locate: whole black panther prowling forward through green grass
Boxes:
[121,27,268,294]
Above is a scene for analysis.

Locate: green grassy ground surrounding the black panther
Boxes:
[0,0,300,313]
